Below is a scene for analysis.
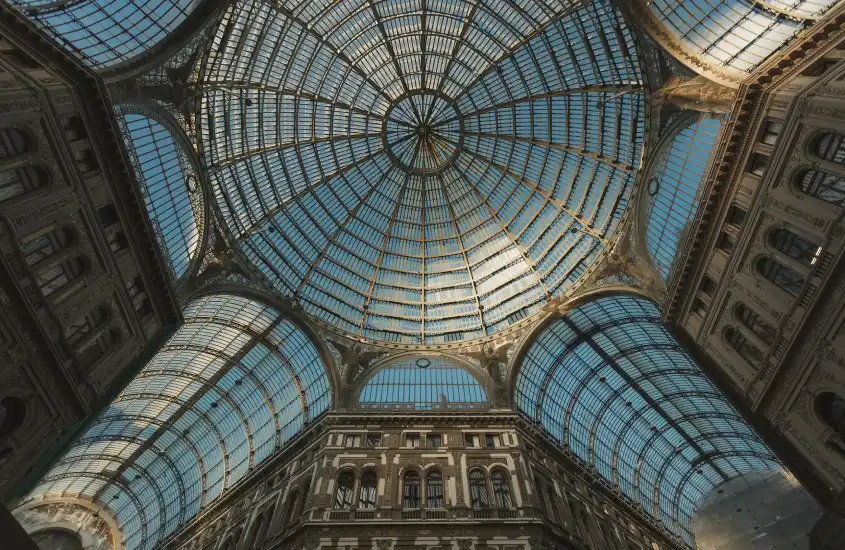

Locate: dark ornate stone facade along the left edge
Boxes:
[0,7,177,498]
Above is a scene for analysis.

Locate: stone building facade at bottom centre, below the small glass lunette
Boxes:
[157,411,678,550]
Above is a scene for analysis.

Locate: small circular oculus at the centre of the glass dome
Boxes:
[382,90,464,175]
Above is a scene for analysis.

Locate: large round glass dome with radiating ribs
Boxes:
[199,0,645,344]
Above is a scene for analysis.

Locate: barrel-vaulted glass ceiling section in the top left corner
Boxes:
[10,0,199,68]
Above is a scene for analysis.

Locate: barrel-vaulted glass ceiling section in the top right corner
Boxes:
[649,0,824,72]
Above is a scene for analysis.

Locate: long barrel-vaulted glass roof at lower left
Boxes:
[28,295,331,550]
